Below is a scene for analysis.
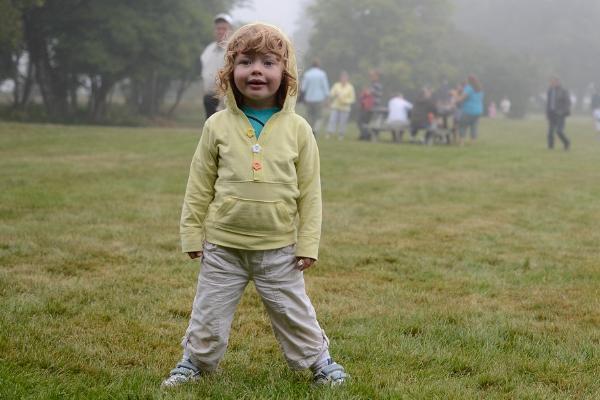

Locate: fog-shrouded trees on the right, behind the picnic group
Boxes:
[307,0,600,117]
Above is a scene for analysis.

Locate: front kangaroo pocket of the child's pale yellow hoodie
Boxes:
[214,196,294,236]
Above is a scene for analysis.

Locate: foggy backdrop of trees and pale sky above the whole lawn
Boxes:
[0,0,600,124]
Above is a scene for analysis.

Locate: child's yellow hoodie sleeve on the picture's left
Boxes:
[179,123,218,253]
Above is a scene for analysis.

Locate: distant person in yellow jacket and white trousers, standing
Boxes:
[327,71,356,140]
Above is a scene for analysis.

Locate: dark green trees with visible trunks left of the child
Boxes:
[0,0,240,122]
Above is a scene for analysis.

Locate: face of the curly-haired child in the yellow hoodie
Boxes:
[233,53,283,108]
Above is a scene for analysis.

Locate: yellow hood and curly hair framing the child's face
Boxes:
[217,22,298,113]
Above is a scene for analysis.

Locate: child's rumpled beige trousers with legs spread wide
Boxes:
[181,243,329,372]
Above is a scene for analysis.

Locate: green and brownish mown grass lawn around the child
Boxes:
[0,119,600,399]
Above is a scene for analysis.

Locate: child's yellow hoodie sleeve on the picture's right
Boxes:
[296,126,322,260]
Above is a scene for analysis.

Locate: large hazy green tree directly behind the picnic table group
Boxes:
[309,0,454,94]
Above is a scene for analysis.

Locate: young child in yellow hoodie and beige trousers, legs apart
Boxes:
[163,23,347,387]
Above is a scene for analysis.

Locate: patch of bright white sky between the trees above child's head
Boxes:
[231,0,302,37]
